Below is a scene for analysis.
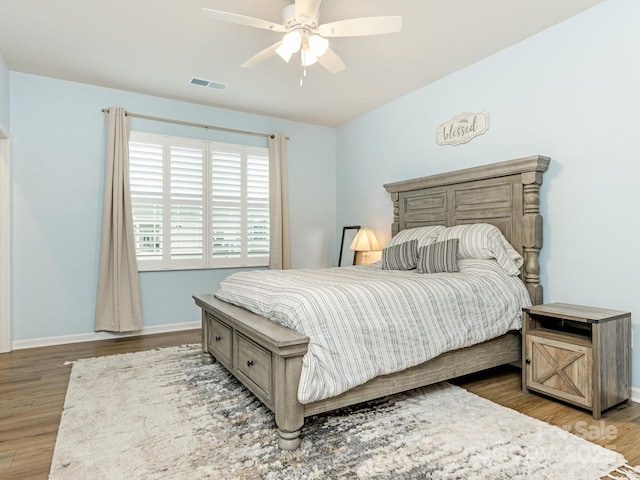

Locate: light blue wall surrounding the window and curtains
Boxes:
[10,72,336,341]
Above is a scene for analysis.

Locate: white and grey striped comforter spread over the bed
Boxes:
[216,259,530,403]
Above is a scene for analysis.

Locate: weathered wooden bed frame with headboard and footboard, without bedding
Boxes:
[193,156,550,450]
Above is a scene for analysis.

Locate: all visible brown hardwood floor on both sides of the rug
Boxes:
[0,330,640,480]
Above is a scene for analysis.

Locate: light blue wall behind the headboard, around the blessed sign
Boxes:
[337,0,640,387]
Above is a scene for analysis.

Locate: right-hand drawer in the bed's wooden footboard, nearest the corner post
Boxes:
[235,332,272,403]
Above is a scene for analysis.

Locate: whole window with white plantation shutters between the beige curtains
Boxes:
[129,132,269,270]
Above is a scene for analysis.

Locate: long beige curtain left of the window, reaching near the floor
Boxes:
[95,107,142,332]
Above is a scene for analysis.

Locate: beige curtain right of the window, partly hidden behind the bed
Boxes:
[269,133,290,270]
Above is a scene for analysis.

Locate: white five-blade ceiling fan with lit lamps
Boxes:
[202,0,402,74]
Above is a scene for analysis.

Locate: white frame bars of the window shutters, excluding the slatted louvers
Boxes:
[129,131,269,271]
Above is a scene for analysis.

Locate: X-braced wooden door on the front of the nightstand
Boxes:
[524,333,593,408]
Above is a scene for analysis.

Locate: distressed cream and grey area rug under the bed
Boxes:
[49,345,634,480]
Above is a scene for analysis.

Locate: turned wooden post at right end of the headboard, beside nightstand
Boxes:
[522,167,549,305]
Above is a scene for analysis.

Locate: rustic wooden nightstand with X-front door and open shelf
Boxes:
[522,303,631,420]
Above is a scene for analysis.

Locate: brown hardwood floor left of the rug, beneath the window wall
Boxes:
[0,330,201,480]
